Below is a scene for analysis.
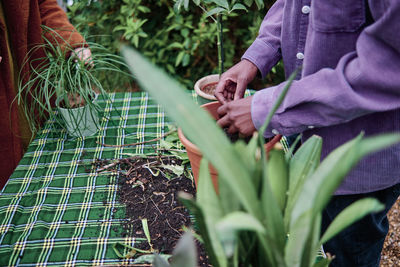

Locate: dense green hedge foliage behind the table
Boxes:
[68,0,283,90]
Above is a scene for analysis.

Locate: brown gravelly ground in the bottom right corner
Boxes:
[380,198,400,267]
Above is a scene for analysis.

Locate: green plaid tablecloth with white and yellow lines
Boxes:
[0,93,288,266]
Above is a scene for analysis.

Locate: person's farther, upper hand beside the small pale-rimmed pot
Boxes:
[215,59,258,104]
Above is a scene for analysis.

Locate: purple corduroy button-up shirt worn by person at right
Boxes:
[243,0,400,195]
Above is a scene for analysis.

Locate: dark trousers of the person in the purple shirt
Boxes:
[322,184,400,267]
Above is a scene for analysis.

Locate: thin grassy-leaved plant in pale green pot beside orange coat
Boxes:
[15,26,126,138]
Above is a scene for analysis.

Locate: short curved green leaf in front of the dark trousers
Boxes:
[320,198,385,244]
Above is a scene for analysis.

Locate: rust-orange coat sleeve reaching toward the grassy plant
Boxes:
[39,0,87,48]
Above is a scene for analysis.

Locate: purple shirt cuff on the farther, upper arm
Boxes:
[242,39,281,78]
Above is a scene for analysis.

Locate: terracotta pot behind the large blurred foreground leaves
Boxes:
[178,102,282,193]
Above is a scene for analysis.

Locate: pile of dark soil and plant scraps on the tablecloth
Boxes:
[97,156,210,266]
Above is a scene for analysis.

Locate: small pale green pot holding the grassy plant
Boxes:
[56,94,99,137]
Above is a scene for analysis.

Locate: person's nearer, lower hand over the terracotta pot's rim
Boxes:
[217,96,256,136]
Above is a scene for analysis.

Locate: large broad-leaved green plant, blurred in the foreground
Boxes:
[123,48,400,267]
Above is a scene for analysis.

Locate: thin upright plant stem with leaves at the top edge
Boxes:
[174,0,264,75]
